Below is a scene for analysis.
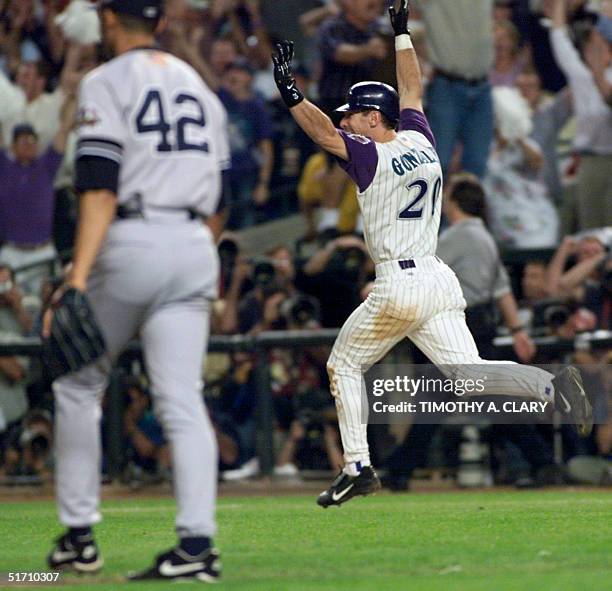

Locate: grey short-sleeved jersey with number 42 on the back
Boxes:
[76,48,230,215]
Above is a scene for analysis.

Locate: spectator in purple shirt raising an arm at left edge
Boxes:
[0,97,76,295]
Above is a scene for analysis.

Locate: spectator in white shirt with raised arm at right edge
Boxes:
[549,0,612,230]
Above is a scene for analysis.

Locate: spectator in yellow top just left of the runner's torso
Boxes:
[297,151,361,240]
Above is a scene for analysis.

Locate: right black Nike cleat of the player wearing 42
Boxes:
[128,547,221,583]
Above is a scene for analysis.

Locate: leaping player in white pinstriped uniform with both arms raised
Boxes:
[272,0,592,507]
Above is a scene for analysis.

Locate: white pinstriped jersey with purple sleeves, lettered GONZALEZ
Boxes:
[340,109,442,264]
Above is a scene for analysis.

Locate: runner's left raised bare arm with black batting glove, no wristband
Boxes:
[272,41,349,160]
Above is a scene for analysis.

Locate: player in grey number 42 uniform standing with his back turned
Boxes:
[43,0,229,582]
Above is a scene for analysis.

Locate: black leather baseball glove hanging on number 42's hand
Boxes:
[42,287,106,380]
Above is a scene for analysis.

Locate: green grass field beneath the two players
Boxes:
[0,490,612,591]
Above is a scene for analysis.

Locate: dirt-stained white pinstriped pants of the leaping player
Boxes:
[327,256,553,463]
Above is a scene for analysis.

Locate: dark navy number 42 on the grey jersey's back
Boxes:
[136,90,208,152]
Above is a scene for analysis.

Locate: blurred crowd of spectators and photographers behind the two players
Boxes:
[0,0,612,488]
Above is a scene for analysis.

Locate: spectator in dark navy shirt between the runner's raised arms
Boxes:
[319,0,387,115]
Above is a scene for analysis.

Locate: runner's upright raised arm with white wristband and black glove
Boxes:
[389,0,423,111]
